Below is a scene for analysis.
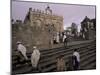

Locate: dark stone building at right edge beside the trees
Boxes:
[81,16,96,40]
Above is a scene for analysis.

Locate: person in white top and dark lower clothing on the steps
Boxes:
[73,49,80,70]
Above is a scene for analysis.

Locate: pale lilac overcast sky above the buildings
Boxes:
[11,1,95,30]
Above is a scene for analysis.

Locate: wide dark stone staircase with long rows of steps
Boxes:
[12,41,96,75]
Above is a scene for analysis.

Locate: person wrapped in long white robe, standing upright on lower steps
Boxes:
[31,46,40,70]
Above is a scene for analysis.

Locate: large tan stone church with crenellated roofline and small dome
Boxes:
[12,6,64,49]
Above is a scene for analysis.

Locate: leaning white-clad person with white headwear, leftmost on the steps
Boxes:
[17,41,28,64]
